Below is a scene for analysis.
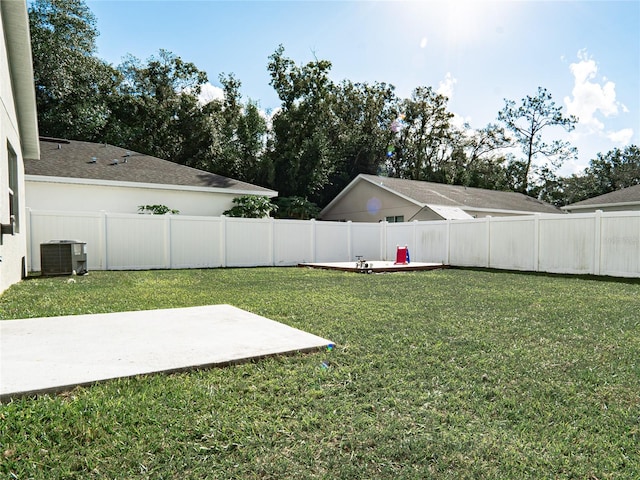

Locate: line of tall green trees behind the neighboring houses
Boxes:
[29,0,640,217]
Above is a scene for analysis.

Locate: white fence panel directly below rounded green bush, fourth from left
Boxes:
[224,217,273,267]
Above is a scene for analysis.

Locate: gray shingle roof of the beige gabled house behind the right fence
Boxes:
[360,174,562,213]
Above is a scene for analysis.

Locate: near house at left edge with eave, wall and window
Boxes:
[0,0,39,292]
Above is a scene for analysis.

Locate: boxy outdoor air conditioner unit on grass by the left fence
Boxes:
[40,240,87,275]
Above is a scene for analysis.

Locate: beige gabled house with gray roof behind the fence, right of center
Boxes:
[319,174,562,222]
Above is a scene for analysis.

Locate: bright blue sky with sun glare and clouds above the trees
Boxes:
[86,0,640,175]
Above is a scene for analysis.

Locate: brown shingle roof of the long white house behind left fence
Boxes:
[24,137,277,197]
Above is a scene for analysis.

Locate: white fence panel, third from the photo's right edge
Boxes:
[489,217,537,271]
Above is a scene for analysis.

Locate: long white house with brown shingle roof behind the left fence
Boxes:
[25,138,277,216]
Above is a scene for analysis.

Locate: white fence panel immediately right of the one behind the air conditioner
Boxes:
[105,213,170,270]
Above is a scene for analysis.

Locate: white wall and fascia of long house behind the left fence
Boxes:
[26,175,268,216]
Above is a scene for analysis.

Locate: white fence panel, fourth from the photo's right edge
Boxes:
[449,218,489,267]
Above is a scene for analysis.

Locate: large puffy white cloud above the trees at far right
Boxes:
[564,50,633,143]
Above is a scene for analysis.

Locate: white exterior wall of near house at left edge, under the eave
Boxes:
[0,4,27,293]
